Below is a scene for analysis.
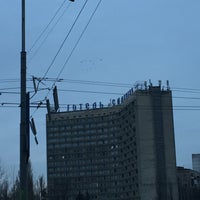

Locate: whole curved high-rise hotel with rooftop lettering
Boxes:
[47,82,178,200]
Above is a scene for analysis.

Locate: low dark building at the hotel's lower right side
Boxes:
[177,167,200,200]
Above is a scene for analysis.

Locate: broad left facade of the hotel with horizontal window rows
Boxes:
[47,109,125,199]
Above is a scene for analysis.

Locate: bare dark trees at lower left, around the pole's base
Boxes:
[0,162,46,200]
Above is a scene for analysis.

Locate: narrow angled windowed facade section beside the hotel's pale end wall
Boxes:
[119,97,139,200]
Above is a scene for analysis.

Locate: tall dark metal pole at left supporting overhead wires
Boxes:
[20,0,29,200]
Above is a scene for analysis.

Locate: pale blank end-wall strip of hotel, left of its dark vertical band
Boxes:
[136,91,157,200]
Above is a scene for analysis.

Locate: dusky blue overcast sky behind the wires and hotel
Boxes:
[0,0,200,180]
